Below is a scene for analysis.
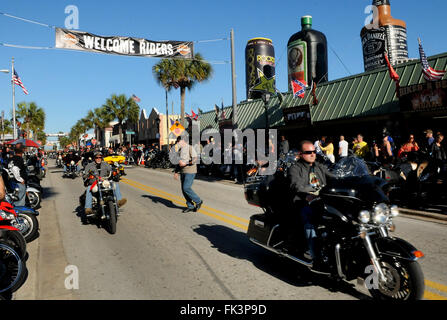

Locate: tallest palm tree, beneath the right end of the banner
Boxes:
[152,53,213,125]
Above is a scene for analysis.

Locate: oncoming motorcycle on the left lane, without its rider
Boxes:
[79,172,119,234]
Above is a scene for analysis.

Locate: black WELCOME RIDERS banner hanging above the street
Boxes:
[56,28,193,59]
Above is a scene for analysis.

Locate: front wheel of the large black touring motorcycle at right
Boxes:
[368,257,425,301]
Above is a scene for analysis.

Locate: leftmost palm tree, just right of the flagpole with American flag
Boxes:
[16,102,45,138]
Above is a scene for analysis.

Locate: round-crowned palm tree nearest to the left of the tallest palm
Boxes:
[103,94,140,143]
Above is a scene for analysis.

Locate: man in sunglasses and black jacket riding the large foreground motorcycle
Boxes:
[289,140,335,260]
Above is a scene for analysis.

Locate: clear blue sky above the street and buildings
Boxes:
[0,0,447,133]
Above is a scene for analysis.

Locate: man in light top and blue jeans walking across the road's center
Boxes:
[174,136,203,212]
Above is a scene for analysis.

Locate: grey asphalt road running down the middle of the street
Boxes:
[19,163,447,300]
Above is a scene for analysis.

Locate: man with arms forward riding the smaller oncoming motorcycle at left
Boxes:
[83,152,127,218]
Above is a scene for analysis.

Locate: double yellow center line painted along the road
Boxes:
[121,178,447,300]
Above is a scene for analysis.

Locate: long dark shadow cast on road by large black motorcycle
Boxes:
[193,224,371,300]
